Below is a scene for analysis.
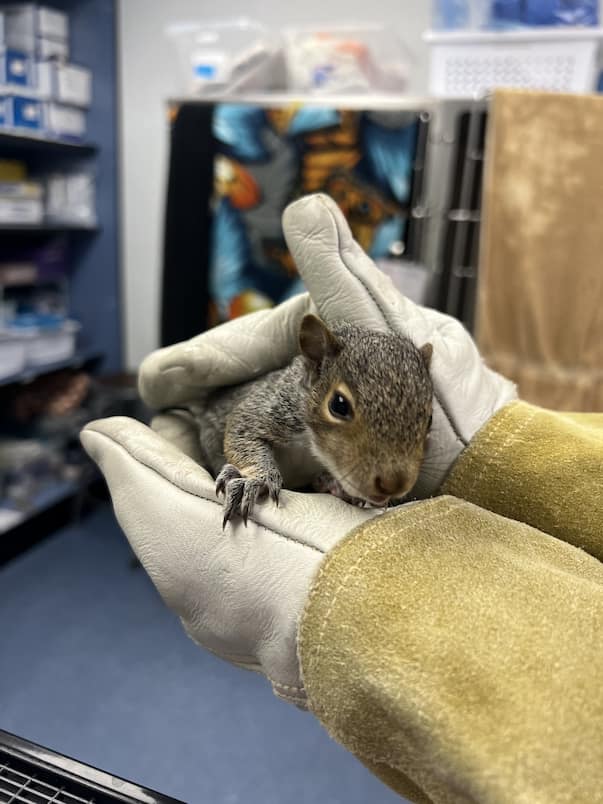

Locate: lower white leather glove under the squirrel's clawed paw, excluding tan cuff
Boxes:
[81,413,378,707]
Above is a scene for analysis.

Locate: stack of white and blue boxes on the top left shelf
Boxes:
[0,3,92,142]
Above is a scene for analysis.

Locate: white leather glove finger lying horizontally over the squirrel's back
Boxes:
[138,293,315,410]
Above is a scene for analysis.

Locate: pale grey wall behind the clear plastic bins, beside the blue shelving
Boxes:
[119,0,430,368]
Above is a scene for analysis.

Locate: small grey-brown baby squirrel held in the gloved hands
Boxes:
[196,315,433,526]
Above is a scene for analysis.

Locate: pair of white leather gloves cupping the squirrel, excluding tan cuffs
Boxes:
[82,195,516,706]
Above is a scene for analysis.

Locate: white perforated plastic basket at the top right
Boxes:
[423,27,603,98]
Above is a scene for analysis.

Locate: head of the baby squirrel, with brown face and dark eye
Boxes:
[299,315,433,505]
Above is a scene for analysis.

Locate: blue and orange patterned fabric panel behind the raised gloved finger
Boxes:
[210,104,417,323]
